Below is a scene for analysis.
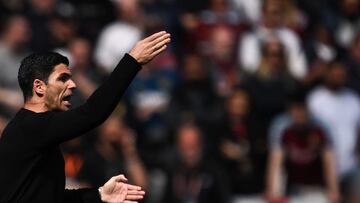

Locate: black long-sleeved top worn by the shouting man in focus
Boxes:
[0,55,141,203]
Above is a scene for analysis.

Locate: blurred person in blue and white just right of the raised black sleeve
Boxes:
[125,49,179,169]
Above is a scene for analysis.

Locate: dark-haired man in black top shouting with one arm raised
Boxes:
[0,32,170,203]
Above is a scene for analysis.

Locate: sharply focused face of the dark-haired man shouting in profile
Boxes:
[44,64,76,111]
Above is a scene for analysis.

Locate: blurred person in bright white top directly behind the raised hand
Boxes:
[95,0,145,73]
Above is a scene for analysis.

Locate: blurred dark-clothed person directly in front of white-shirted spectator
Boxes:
[243,40,298,151]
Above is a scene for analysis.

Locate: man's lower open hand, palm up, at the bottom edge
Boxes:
[100,175,145,203]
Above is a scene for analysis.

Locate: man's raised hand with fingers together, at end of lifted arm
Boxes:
[129,31,170,65]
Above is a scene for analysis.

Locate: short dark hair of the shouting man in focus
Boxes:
[18,52,69,101]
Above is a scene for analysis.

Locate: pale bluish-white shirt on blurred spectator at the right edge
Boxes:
[308,87,360,175]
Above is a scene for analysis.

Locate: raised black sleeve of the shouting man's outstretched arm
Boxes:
[39,54,141,146]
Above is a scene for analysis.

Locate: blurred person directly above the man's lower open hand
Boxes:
[77,115,148,189]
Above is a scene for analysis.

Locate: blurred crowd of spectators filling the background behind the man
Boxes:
[0,0,360,203]
